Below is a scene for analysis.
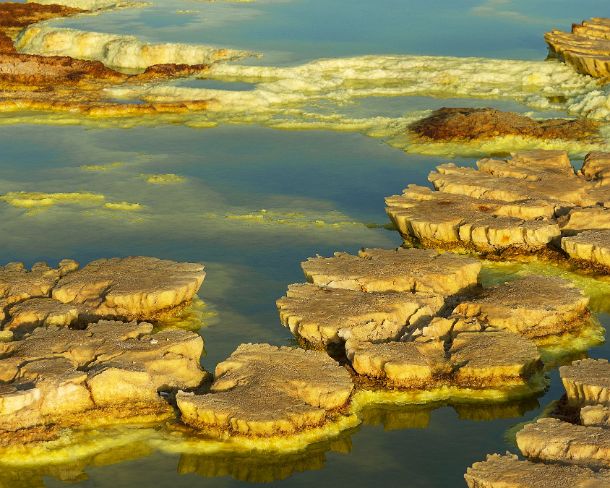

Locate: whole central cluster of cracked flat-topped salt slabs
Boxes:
[277,249,600,397]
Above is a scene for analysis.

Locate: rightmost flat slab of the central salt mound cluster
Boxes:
[453,275,590,339]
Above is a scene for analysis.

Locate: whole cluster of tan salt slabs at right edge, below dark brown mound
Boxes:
[386,150,610,271]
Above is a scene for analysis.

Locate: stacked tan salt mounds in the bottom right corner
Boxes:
[465,359,610,488]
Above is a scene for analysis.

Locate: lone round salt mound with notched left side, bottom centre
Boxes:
[176,344,354,440]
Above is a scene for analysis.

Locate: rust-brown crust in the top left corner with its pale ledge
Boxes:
[0,2,238,116]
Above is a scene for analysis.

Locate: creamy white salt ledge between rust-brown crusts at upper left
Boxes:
[15,25,251,69]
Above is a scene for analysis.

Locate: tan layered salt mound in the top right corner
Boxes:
[544,18,610,78]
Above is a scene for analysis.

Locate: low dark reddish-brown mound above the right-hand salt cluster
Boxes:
[409,107,598,142]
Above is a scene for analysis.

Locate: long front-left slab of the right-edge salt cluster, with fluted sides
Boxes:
[386,185,561,252]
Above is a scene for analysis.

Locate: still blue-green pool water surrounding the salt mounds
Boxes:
[0,0,610,488]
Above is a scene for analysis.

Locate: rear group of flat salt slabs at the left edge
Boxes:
[0,256,205,335]
